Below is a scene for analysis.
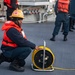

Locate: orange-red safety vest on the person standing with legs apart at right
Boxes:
[58,0,70,13]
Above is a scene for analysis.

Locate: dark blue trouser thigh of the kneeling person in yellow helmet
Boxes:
[3,47,31,60]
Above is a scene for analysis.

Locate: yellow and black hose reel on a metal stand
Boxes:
[32,46,55,71]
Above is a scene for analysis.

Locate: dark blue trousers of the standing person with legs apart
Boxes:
[53,12,69,36]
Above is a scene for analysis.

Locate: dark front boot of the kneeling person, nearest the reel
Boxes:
[9,60,25,72]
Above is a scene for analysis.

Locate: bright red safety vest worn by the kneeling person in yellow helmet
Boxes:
[2,21,27,48]
